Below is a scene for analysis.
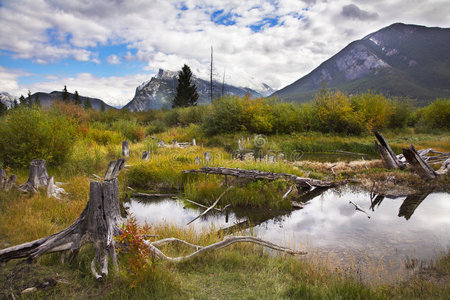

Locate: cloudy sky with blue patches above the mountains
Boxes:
[0,0,450,106]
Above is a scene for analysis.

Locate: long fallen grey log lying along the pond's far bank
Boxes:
[183,167,343,188]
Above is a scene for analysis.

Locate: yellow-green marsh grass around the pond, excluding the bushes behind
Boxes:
[0,125,450,299]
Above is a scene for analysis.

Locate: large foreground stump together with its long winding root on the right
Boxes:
[0,159,306,279]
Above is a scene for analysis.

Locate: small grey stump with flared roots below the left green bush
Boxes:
[17,159,67,199]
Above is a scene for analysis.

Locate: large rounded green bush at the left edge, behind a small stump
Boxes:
[0,107,77,167]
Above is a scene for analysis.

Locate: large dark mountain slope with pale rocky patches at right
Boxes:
[272,23,450,104]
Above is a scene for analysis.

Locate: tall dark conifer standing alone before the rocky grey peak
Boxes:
[172,65,198,107]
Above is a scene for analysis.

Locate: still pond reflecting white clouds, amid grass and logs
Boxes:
[128,186,450,281]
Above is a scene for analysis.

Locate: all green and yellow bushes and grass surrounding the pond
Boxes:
[0,91,450,299]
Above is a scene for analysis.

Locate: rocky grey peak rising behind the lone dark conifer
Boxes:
[123,69,273,111]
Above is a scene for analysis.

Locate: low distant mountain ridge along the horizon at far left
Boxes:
[0,91,115,110]
